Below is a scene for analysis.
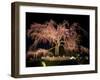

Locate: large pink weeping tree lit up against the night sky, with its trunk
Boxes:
[27,20,88,56]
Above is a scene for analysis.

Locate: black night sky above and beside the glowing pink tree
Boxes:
[26,12,90,51]
